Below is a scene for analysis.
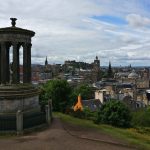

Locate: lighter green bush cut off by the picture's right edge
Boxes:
[132,107,150,127]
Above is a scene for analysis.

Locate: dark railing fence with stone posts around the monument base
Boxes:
[0,100,52,134]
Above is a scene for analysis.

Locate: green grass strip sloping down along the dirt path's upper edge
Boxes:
[54,113,150,150]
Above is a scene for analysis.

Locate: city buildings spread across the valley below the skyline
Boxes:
[30,56,150,109]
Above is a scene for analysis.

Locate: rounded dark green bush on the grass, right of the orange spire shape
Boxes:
[95,100,131,127]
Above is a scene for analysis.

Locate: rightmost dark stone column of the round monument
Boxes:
[23,43,31,83]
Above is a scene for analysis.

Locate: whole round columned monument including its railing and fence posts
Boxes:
[0,18,49,132]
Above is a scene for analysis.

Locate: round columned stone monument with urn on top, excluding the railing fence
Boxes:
[0,18,45,132]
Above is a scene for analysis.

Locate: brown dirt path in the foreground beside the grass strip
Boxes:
[0,118,137,150]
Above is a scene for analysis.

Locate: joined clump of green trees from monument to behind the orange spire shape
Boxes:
[40,80,93,112]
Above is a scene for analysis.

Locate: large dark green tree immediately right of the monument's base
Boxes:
[40,80,71,112]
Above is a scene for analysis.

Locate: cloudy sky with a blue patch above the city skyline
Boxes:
[0,0,150,66]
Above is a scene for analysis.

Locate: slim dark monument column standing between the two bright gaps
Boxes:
[12,42,20,84]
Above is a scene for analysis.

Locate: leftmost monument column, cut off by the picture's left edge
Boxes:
[0,42,6,84]
